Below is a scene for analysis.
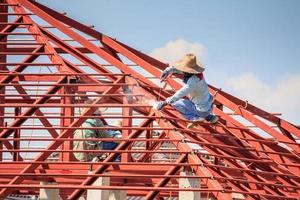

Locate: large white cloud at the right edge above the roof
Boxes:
[226,73,300,125]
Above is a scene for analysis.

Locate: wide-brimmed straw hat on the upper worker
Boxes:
[173,53,205,74]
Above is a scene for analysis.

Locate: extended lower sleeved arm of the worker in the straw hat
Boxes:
[166,76,197,104]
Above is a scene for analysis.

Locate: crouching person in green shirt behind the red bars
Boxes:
[73,99,122,162]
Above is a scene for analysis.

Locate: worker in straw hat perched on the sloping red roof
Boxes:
[157,54,218,128]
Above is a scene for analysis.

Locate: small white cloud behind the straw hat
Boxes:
[150,38,207,63]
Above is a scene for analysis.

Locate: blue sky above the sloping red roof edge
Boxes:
[39,0,300,124]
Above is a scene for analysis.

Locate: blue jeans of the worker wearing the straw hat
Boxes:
[171,99,212,120]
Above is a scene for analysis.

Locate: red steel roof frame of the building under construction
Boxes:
[0,0,300,200]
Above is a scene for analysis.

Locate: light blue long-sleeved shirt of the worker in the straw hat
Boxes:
[165,67,213,112]
